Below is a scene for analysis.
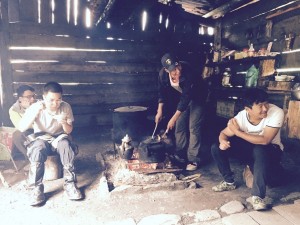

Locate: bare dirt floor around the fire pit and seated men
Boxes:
[0,126,300,225]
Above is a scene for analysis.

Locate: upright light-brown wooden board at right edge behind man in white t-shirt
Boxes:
[287,101,300,139]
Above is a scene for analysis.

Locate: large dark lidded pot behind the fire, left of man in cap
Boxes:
[112,106,148,143]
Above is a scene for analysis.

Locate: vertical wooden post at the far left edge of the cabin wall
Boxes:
[0,0,14,126]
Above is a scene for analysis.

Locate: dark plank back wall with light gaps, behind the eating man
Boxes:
[0,0,211,128]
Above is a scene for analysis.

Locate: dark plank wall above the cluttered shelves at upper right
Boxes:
[221,0,300,52]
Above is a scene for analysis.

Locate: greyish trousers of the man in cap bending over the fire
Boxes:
[175,101,204,162]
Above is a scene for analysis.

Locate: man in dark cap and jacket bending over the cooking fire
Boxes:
[155,53,208,171]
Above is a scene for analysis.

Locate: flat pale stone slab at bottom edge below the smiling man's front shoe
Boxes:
[247,210,293,225]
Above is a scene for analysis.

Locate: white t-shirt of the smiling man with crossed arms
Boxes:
[235,104,284,150]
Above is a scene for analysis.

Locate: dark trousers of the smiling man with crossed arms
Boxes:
[211,137,282,198]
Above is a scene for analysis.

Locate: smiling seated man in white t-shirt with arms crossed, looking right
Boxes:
[211,88,284,210]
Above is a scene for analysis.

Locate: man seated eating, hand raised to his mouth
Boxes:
[19,82,82,205]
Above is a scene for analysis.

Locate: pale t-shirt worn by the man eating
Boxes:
[26,102,74,136]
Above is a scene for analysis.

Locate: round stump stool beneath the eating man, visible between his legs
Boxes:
[44,154,63,180]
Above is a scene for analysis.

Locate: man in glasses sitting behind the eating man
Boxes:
[9,85,35,156]
